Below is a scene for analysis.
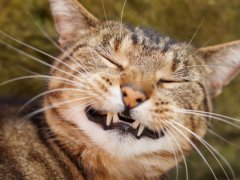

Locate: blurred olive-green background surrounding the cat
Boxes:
[0,0,240,180]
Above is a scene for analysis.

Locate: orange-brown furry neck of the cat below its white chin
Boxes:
[46,107,165,179]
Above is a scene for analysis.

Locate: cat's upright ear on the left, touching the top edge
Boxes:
[50,0,100,48]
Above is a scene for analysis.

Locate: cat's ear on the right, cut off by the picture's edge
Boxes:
[199,40,240,97]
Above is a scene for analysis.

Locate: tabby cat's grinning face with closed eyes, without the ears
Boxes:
[46,22,210,154]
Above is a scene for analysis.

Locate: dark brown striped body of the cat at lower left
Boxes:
[0,99,81,179]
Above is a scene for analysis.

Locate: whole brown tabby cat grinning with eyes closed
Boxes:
[0,0,240,179]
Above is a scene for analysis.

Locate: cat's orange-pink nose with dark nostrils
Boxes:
[121,85,147,108]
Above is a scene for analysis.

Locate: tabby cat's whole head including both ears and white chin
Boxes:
[45,0,240,176]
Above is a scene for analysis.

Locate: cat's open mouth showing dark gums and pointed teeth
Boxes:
[86,108,164,139]
